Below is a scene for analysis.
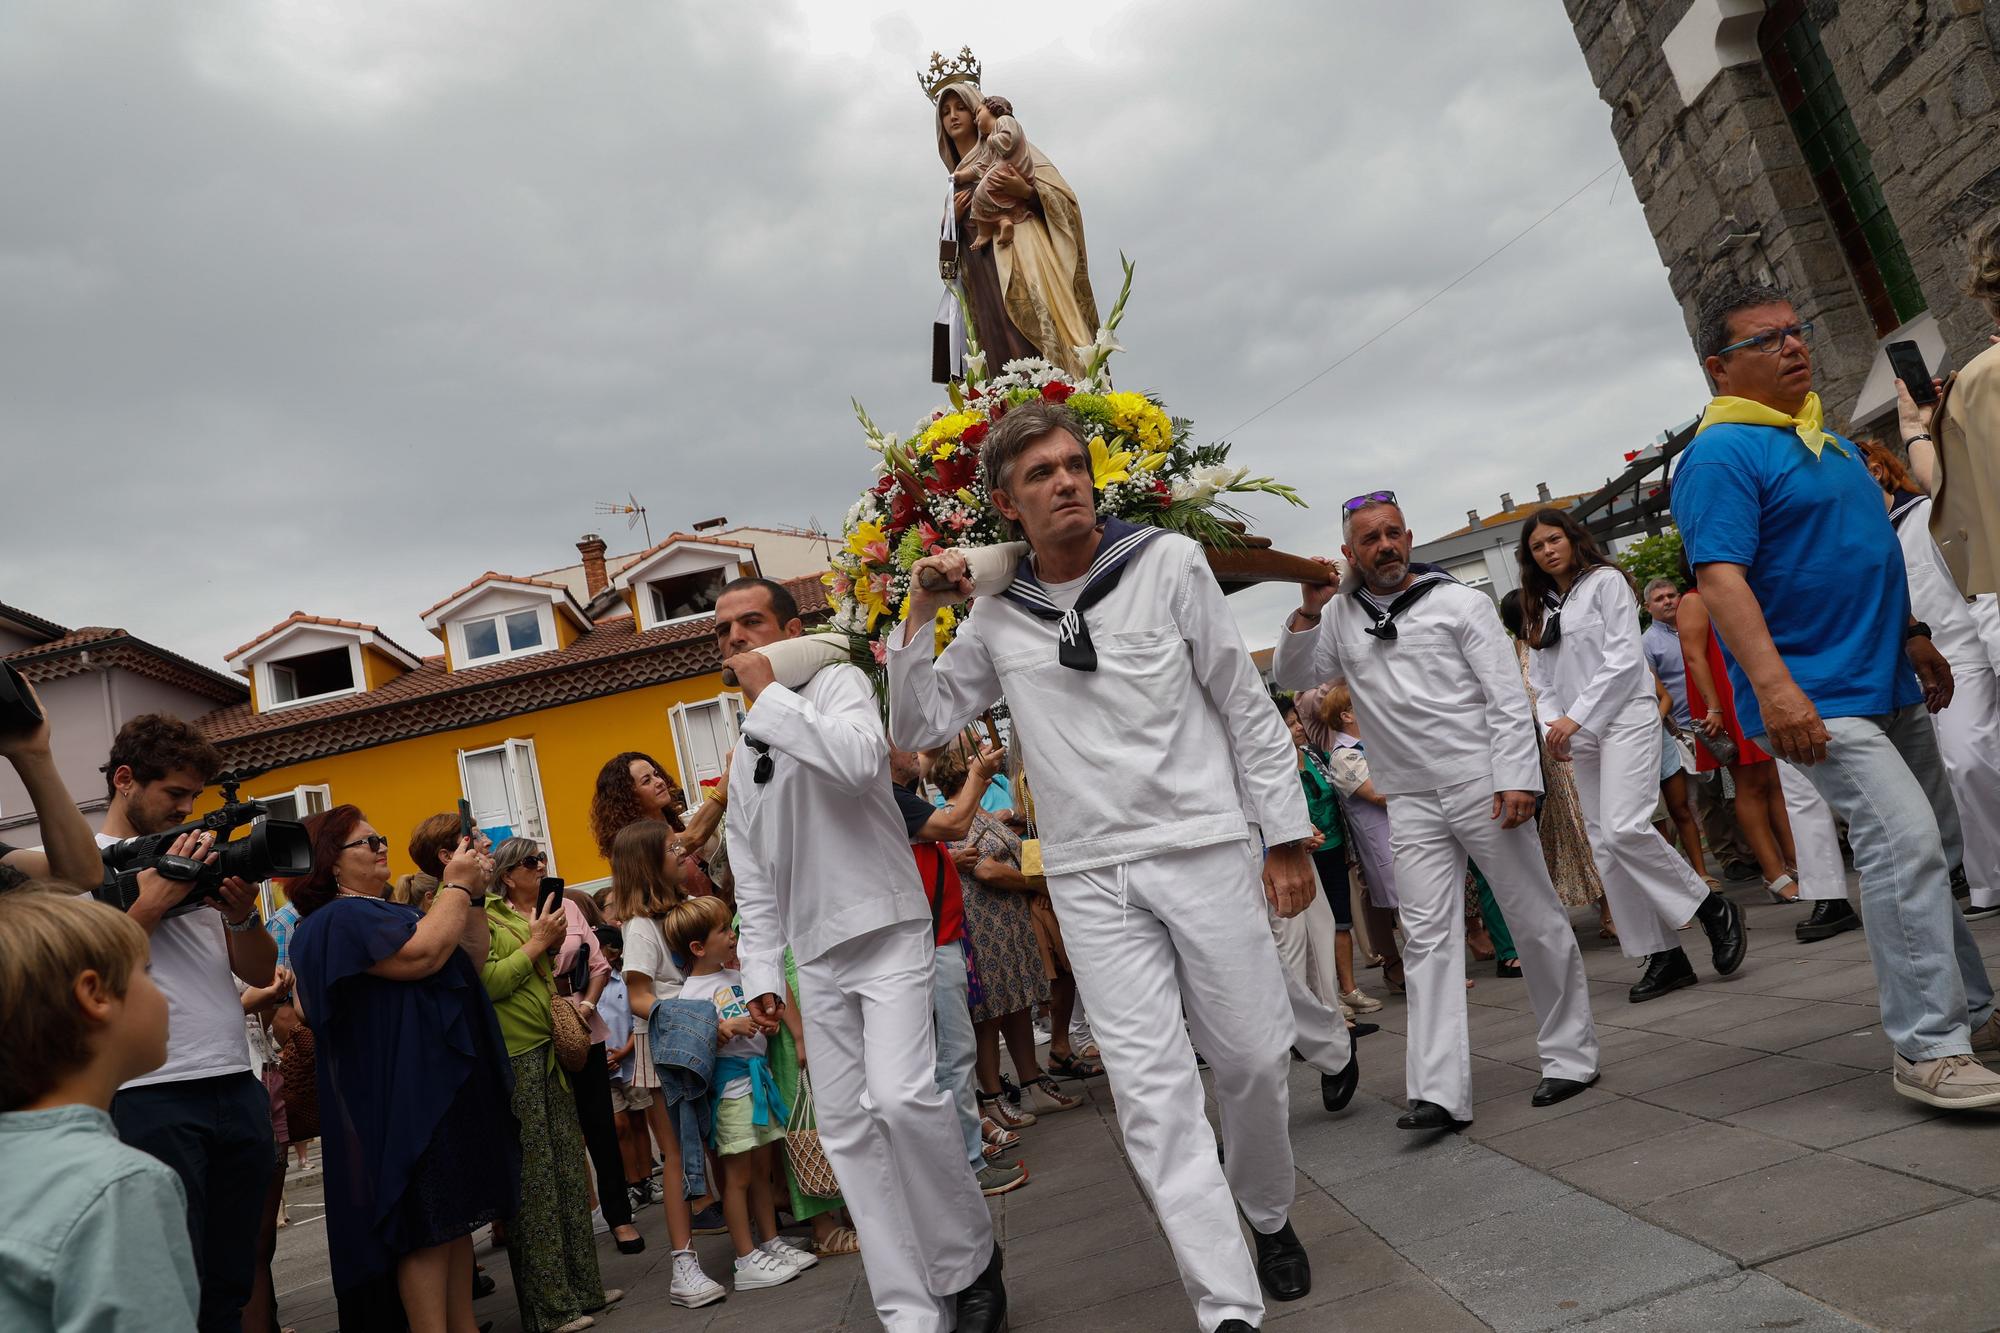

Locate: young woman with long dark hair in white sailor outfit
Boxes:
[1518,508,1744,1005]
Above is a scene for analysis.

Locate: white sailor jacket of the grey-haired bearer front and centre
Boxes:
[892,532,1312,875]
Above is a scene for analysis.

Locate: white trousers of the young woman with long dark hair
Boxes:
[1568,695,1708,959]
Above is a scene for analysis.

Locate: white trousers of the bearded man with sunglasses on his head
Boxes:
[1388,772,1592,1121]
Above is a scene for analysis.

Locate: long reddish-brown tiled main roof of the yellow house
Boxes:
[196,576,830,769]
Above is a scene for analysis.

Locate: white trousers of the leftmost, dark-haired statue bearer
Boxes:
[798,921,994,1333]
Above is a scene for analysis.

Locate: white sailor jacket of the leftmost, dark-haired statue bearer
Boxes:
[730,662,930,997]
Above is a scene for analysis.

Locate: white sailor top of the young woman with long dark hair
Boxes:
[1528,568,1654,737]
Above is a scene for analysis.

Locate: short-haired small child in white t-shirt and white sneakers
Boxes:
[660,897,820,1291]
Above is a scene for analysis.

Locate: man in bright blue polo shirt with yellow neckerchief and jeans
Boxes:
[1674,286,2000,1109]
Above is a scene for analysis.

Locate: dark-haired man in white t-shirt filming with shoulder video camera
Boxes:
[10,713,278,1333]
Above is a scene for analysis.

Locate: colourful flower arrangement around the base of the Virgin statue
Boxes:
[826,256,1304,664]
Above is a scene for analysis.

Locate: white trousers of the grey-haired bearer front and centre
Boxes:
[1048,841,1296,1331]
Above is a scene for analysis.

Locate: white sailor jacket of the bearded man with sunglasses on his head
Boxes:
[1270,582,1542,797]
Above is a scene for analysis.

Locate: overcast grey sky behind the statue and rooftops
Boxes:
[0,0,1706,667]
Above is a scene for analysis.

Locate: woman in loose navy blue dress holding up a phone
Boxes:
[286,805,520,1333]
